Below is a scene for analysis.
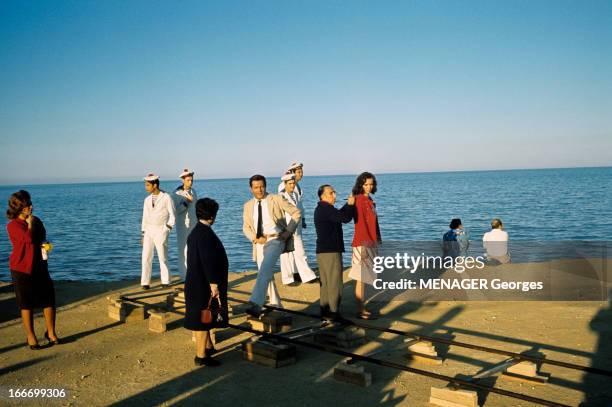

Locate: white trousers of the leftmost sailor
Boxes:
[140,225,170,285]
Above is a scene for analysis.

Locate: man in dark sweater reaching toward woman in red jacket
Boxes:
[314,185,355,320]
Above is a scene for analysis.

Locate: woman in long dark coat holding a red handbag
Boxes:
[185,198,229,366]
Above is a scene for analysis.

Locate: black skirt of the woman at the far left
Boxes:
[11,261,55,310]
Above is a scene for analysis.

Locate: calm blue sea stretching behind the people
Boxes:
[0,167,612,281]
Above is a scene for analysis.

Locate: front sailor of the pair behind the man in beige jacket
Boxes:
[280,172,317,284]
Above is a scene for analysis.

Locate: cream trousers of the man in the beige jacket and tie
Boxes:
[250,238,285,307]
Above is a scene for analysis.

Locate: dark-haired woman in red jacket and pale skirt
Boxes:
[349,172,381,319]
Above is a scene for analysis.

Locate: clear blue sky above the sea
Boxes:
[0,0,612,184]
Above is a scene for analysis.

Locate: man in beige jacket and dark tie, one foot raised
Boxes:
[242,174,302,317]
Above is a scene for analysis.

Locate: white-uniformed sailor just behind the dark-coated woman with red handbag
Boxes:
[172,168,198,280]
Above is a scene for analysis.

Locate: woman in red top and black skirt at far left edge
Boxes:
[6,190,59,349]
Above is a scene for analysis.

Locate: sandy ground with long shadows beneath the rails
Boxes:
[0,273,612,407]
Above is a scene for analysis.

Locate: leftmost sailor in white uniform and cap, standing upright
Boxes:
[140,174,175,290]
